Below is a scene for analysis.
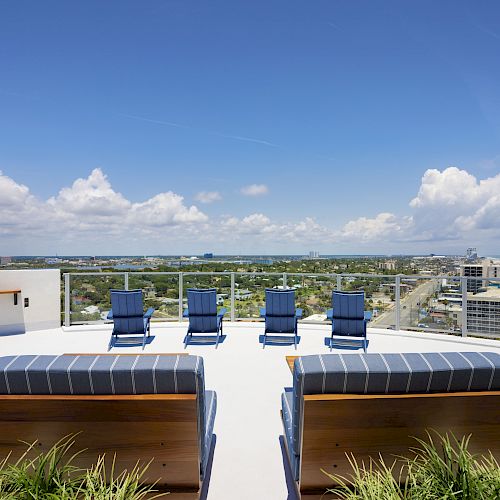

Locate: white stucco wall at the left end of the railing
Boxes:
[0,269,61,335]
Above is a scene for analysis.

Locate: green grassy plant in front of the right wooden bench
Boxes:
[323,433,500,500]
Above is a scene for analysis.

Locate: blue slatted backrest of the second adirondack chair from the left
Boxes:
[187,288,218,333]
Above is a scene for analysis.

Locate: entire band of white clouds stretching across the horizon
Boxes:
[0,167,500,255]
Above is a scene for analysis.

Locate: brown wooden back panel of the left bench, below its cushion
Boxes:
[0,353,213,499]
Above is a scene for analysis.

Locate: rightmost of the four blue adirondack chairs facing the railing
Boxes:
[326,291,372,352]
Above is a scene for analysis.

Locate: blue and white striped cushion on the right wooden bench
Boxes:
[292,352,500,455]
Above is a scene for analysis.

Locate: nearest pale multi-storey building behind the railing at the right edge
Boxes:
[467,286,500,337]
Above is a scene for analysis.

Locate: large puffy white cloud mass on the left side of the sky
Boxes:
[0,169,208,246]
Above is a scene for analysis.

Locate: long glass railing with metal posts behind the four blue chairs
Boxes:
[63,272,500,338]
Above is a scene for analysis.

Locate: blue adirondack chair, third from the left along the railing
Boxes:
[260,288,302,349]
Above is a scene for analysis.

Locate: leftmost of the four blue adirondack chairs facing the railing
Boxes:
[108,290,155,351]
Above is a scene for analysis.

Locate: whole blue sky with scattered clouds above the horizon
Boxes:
[0,0,500,254]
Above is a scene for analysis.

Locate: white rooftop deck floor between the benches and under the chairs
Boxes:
[0,323,500,500]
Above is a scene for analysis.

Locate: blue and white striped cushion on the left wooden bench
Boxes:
[0,354,217,474]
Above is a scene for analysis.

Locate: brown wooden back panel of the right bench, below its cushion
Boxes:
[284,391,500,499]
